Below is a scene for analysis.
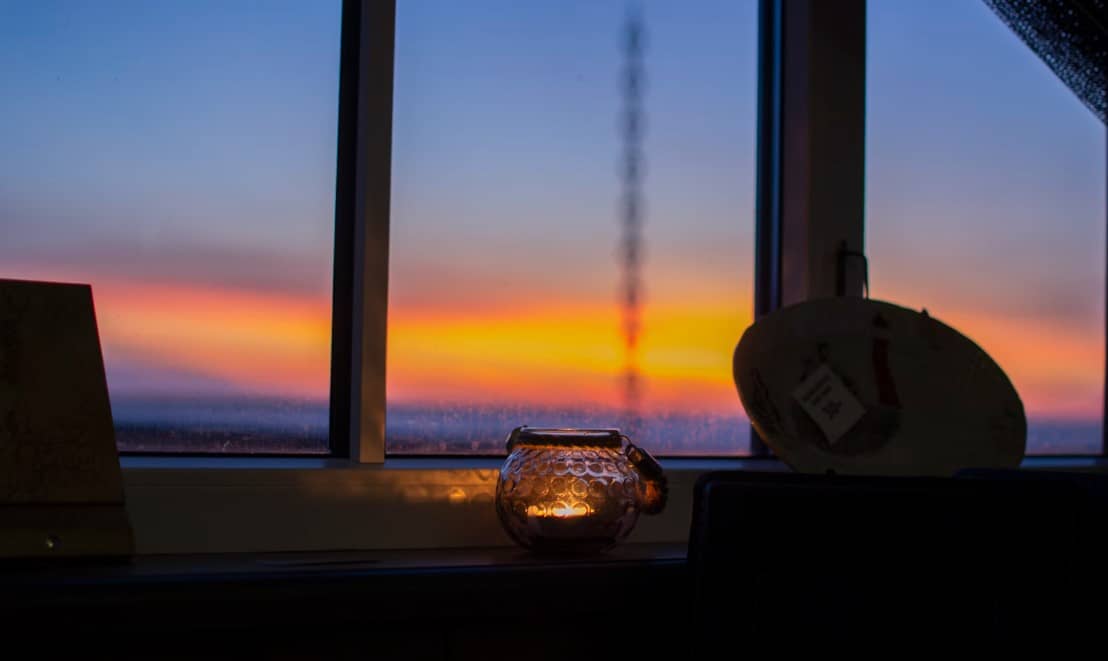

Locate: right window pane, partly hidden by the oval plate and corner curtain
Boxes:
[866,0,1106,454]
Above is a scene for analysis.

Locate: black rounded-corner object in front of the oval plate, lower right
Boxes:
[688,472,1105,645]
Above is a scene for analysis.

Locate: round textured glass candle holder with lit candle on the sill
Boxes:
[496,426,666,551]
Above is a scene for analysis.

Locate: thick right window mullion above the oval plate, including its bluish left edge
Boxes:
[750,0,865,455]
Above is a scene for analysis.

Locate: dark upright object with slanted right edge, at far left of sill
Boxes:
[0,275,133,560]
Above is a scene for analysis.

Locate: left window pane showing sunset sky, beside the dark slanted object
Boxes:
[0,0,340,453]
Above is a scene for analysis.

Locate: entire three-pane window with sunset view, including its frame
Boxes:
[0,0,1105,552]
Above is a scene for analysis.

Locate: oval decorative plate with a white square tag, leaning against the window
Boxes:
[733,297,1027,475]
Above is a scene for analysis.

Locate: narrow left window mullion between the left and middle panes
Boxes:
[329,0,397,464]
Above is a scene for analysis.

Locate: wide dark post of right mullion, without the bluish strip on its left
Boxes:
[778,0,865,306]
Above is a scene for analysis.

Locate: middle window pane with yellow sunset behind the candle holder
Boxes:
[387,0,757,454]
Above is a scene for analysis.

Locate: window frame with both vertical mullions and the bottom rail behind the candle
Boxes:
[114,0,1108,552]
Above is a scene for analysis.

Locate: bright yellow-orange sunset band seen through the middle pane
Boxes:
[389,304,749,412]
